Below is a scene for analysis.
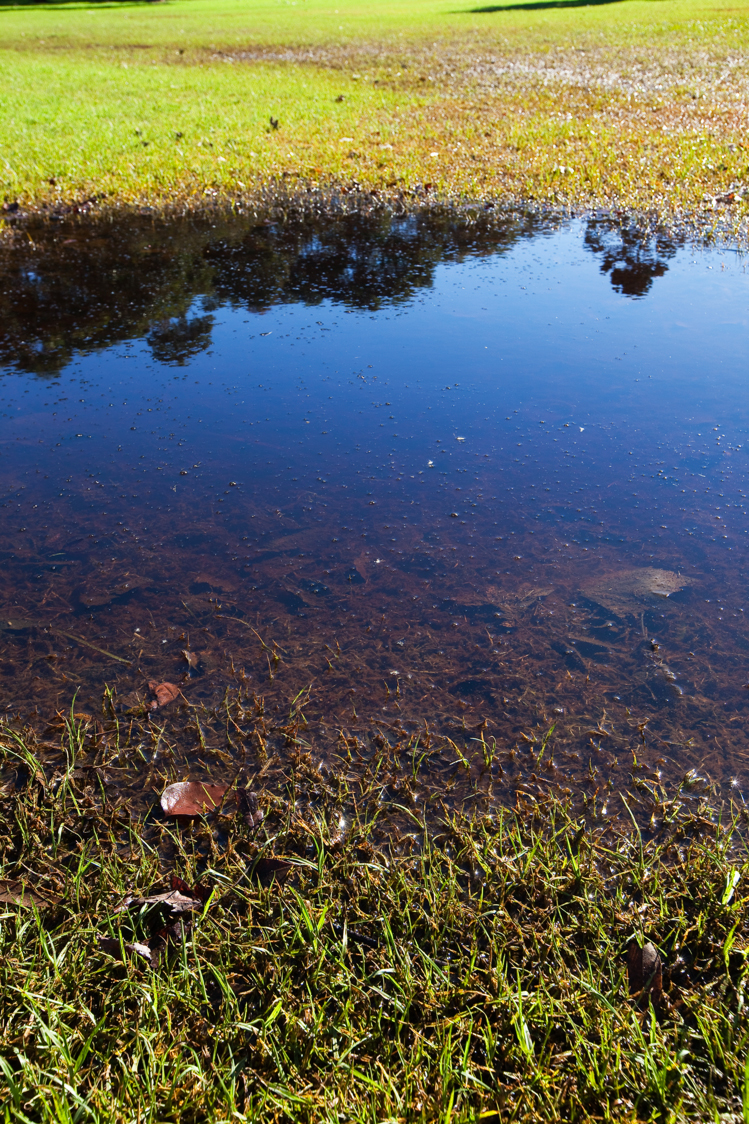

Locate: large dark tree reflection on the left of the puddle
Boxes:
[0,211,542,374]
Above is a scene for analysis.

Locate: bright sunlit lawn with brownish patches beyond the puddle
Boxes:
[0,0,749,214]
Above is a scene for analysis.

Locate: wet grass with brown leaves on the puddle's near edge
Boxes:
[0,717,749,1122]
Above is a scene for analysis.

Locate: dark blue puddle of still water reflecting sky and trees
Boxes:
[0,215,749,810]
